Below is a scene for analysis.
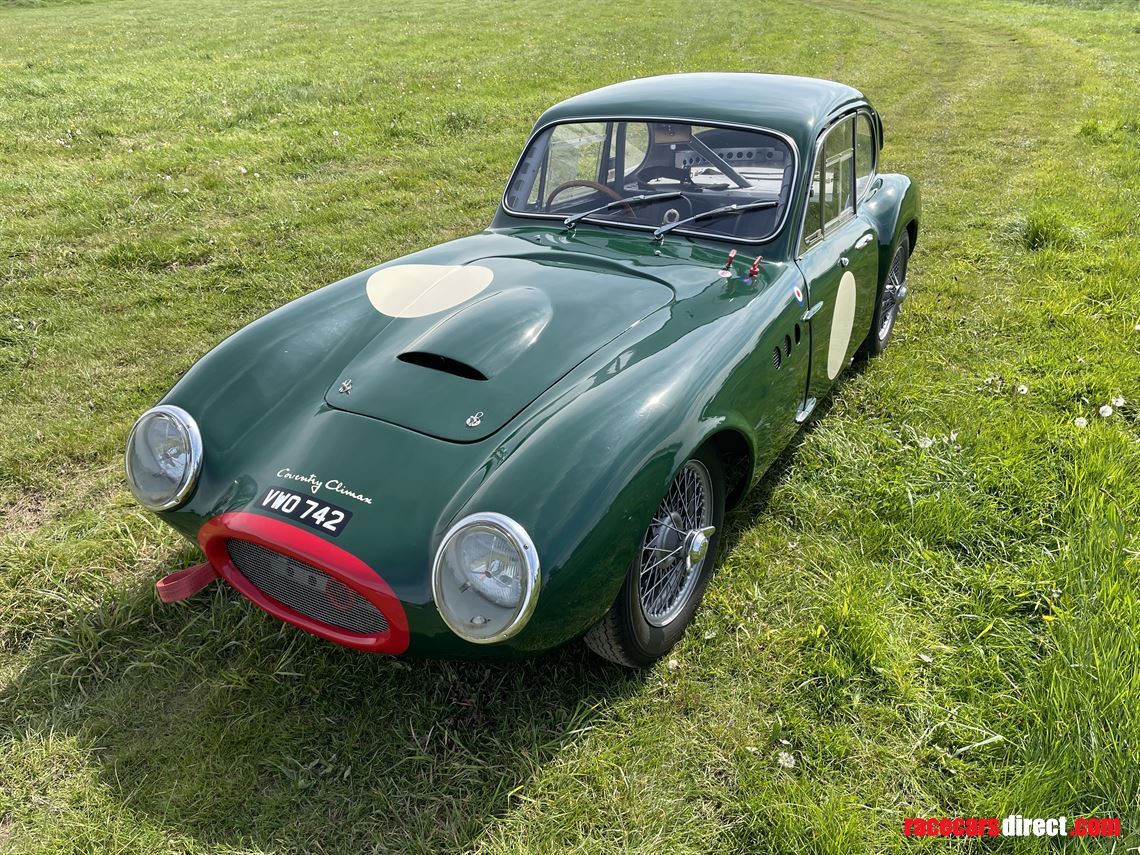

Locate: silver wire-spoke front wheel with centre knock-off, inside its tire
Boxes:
[637,459,713,627]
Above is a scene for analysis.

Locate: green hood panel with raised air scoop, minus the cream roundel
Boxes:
[325,258,673,442]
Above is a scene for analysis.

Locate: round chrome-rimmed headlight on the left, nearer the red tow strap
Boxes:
[127,404,202,511]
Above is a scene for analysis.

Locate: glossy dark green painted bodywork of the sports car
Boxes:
[149,74,919,657]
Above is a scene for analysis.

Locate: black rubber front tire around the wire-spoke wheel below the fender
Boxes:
[585,447,725,668]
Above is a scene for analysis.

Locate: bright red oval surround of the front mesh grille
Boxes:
[198,512,408,653]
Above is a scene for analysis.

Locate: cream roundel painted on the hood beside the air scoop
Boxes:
[365,264,495,318]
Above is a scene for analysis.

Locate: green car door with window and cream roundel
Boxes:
[797,114,879,412]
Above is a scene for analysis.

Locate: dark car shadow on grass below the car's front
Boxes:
[0,572,644,852]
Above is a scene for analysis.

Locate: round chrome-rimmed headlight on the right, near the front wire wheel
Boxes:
[431,513,540,644]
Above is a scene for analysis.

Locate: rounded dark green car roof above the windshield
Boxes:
[536,72,866,150]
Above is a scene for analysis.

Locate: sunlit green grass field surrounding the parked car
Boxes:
[0,0,1140,855]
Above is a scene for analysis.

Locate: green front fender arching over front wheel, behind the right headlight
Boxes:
[444,291,756,651]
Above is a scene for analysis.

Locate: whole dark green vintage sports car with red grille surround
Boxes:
[127,74,919,666]
